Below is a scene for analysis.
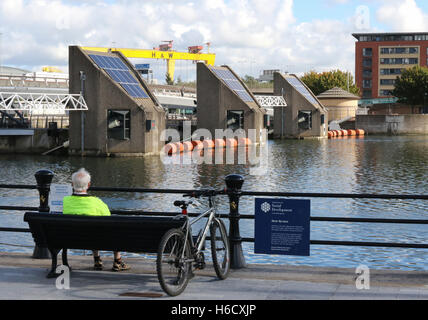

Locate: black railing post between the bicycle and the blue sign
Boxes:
[225,174,247,269]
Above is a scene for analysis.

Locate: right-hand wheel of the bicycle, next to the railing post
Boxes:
[210,219,230,280]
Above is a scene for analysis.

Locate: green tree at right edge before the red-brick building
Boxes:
[392,66,428,106]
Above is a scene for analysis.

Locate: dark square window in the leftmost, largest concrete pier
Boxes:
[107,110,131,140]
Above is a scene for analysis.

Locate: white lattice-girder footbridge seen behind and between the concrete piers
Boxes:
[0,74,287,135]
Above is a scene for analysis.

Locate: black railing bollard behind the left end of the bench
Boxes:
[33,169,54,259]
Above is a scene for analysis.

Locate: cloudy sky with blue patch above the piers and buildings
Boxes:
[0,0,428,82]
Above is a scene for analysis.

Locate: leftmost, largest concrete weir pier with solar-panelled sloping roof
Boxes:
[69,46,166,156]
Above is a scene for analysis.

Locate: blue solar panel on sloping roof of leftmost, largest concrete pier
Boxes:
[89,54,149,98]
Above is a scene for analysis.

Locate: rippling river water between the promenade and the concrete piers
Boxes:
[0,136,428,270]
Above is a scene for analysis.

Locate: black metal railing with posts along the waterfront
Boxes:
[0,170,428,269]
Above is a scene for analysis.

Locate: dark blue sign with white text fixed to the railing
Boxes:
[254,198,311,256]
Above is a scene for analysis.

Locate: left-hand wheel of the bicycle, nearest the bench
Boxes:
[156,229,192,296]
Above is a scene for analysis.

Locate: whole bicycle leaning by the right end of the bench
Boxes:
[156,190,230,296]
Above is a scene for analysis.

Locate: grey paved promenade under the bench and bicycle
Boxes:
[0,252,428,301]
